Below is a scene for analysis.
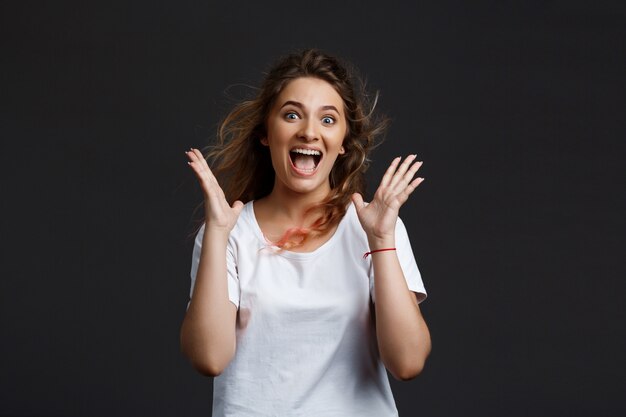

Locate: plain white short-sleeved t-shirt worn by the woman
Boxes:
[191,202,426,417]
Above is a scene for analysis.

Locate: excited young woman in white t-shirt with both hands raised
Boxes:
[181,50,430,417]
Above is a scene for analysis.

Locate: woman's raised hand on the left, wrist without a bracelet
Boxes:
[185,148,243,235]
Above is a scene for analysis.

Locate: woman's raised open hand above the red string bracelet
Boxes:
[352,155,424,250]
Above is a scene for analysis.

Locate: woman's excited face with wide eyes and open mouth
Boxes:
[261,77,347,198]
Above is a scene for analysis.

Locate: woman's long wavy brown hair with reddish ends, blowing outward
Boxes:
[208,49,388,249]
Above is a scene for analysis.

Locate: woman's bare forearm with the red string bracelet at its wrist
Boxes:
[370,237,431,380]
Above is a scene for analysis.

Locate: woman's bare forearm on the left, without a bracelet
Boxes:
[181,230,237,376]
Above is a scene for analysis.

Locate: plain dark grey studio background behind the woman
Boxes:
[0,1,626,417]
